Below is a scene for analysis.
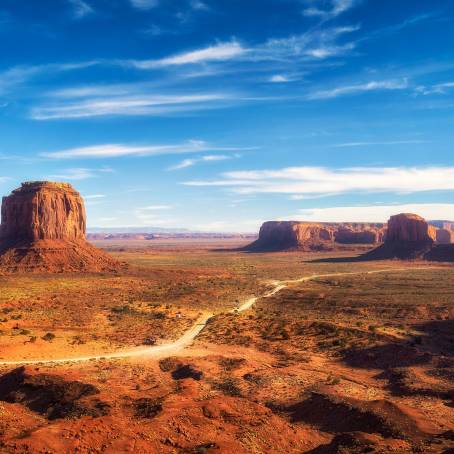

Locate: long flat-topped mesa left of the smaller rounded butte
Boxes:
[245,221,384,252]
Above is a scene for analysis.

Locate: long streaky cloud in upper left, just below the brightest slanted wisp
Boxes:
[31,93,230,120]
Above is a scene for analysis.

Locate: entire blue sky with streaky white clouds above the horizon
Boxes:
[0,0,454,232]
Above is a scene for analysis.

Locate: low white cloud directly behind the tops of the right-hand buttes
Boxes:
[287,203,454,222]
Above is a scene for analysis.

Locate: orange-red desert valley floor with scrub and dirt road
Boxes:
[0,240,454,453]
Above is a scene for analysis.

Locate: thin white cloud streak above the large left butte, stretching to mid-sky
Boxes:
[40,140,247,159]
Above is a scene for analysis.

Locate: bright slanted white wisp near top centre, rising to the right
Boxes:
[129,41,247,69]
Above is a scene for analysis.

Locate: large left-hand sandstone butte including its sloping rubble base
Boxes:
[0,181,121,272]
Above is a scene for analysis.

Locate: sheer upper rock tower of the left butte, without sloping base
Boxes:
[0,181,86,242]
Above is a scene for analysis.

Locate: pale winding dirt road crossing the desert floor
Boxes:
[0,267,433,366]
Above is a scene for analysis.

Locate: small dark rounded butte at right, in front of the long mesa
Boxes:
[366,213,435,259]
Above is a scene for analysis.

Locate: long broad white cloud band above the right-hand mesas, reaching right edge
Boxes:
[183,167,454,195]
